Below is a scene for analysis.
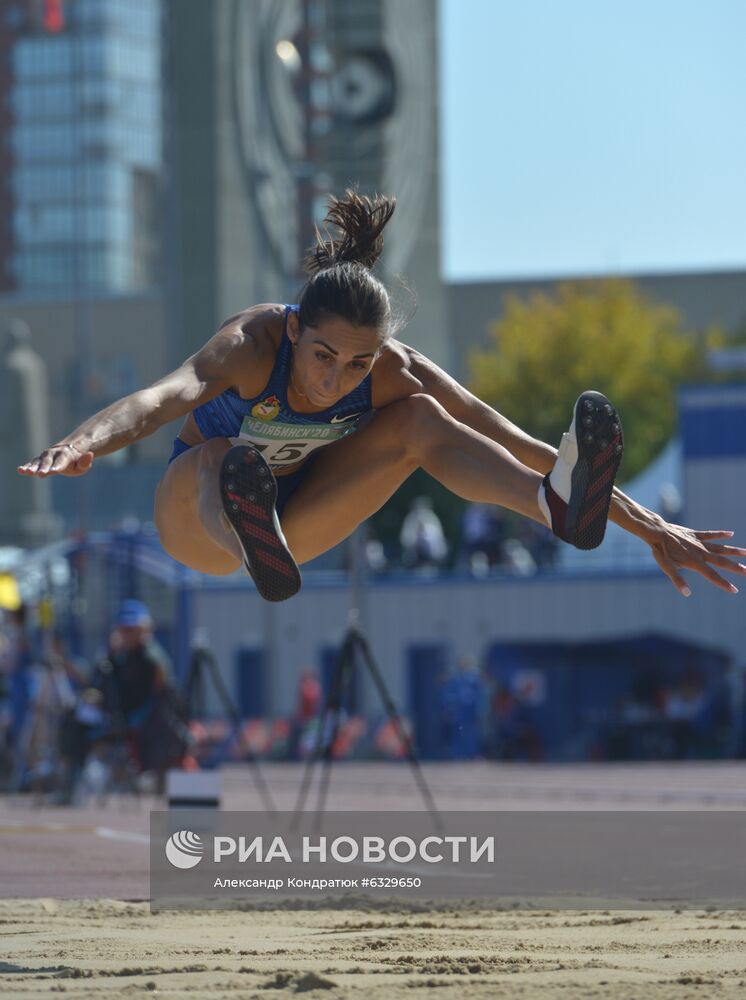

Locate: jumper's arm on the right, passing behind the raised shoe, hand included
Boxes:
[405,348,746,597]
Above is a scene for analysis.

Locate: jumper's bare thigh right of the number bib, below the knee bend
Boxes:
[282,404,416,563]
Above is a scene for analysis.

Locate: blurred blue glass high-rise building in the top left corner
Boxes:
[0,0,163,298]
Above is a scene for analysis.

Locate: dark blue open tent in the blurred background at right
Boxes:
[487,634,730,761]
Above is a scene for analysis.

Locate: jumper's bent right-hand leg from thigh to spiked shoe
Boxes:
[282,393,621,563]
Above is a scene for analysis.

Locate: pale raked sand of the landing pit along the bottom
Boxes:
[0,900,746,1000]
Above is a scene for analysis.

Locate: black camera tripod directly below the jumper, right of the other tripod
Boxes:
[294,609,443,830]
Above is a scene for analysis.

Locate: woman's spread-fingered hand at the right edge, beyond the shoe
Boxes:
[645,520,746,597]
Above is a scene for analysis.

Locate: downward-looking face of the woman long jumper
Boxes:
[288,313,381,409]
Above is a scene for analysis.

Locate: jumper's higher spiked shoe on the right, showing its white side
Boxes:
[539,390,624,549]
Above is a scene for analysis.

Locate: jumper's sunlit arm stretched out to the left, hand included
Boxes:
[18,322,251,476]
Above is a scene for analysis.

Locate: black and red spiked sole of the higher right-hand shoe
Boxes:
[565,391,624,549]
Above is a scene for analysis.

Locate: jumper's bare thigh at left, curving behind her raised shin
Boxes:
[154,445,239,575]
